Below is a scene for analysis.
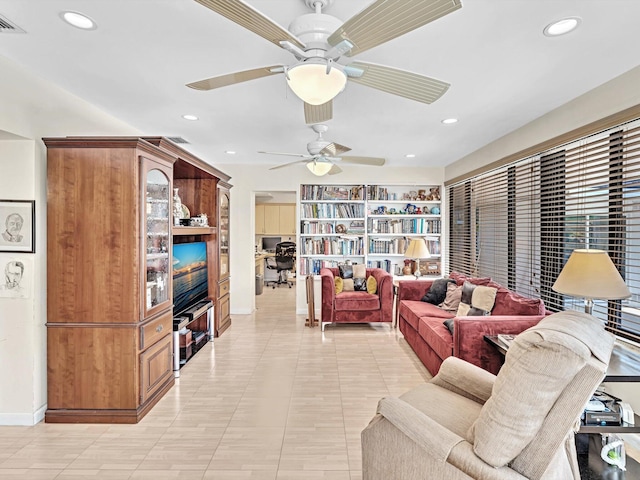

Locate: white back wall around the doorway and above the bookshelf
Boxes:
[216,164,444,314]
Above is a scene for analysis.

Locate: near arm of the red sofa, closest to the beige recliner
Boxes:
[453,315,545,374]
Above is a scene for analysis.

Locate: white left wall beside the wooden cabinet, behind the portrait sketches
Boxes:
[0,56,140,425]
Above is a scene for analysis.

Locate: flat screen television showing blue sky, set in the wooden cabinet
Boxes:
[173,242,209,315]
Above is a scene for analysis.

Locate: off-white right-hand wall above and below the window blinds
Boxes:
[445,63,640,412]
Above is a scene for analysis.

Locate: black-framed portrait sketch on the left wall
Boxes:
[0,200,36,253]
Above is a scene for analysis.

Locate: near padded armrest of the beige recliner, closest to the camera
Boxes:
[378,397,465,463]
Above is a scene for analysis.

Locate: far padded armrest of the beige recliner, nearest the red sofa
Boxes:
[430,357,496,404]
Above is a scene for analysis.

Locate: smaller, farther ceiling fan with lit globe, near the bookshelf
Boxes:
[258,124,385,176]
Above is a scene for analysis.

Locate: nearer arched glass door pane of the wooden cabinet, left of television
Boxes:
[144,168,171,314]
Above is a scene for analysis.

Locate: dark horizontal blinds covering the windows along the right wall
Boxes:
[447,120,640,341]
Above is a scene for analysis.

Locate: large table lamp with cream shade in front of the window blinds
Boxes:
[551,249,631,315]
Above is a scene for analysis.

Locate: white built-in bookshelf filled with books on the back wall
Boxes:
[298,185,442,275]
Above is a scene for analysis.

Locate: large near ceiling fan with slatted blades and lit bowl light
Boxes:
[187,0,462,124]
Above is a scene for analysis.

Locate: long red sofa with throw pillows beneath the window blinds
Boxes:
[397,273,549,375]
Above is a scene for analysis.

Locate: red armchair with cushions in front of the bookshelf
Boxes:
[320,268,393,331]
